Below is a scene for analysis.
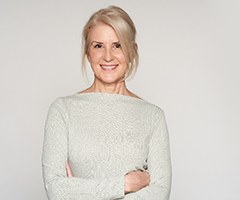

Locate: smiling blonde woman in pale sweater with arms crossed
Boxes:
[42,6,171,200]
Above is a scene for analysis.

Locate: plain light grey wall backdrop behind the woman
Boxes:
[0,0,240,200]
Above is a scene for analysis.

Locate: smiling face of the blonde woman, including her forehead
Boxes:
[87,23,128,84]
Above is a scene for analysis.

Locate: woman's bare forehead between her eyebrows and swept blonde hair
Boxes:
[89,23,119,43]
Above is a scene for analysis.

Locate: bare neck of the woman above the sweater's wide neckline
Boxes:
[87,78,129,95]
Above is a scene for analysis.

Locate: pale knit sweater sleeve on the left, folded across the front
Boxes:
[42,98,124,200]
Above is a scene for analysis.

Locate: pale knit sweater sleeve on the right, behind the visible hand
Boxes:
[124,108,172,200]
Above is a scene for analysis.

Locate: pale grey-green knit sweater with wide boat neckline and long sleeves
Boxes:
[42,92,171,200]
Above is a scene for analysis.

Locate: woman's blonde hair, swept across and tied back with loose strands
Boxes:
[82,6,139,79]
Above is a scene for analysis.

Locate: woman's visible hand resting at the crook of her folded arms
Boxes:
[125,170,150,193]
